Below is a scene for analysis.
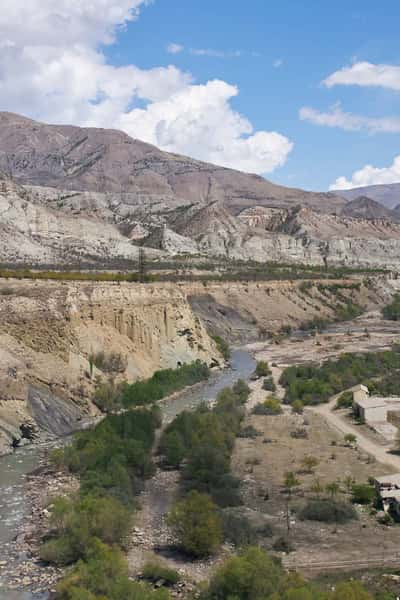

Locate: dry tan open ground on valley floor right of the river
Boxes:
[233,313,400,565]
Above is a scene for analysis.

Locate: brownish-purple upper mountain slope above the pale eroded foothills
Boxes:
[0,112,345,214]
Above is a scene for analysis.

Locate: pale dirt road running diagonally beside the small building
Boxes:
[309,396,400,471]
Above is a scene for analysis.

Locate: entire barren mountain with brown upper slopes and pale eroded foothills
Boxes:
[0,113,400,269]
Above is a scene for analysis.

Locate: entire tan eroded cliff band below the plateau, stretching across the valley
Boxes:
[0,276,398,452]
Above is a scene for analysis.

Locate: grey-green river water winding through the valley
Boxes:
[0,350,255,600]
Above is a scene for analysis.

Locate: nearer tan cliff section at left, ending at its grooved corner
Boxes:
[0,280,222,450]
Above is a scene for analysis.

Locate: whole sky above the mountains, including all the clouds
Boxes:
[0,0,400,190]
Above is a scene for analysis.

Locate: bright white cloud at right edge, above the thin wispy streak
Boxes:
[322,62,400,91]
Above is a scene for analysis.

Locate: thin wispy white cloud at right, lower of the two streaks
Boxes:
[299,103,400,133]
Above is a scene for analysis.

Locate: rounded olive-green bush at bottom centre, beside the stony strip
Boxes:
[167,491,222,558]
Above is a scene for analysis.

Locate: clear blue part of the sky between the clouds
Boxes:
[112,0,400,189]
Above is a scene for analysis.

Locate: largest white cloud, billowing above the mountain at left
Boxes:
[0,0,292,173]
